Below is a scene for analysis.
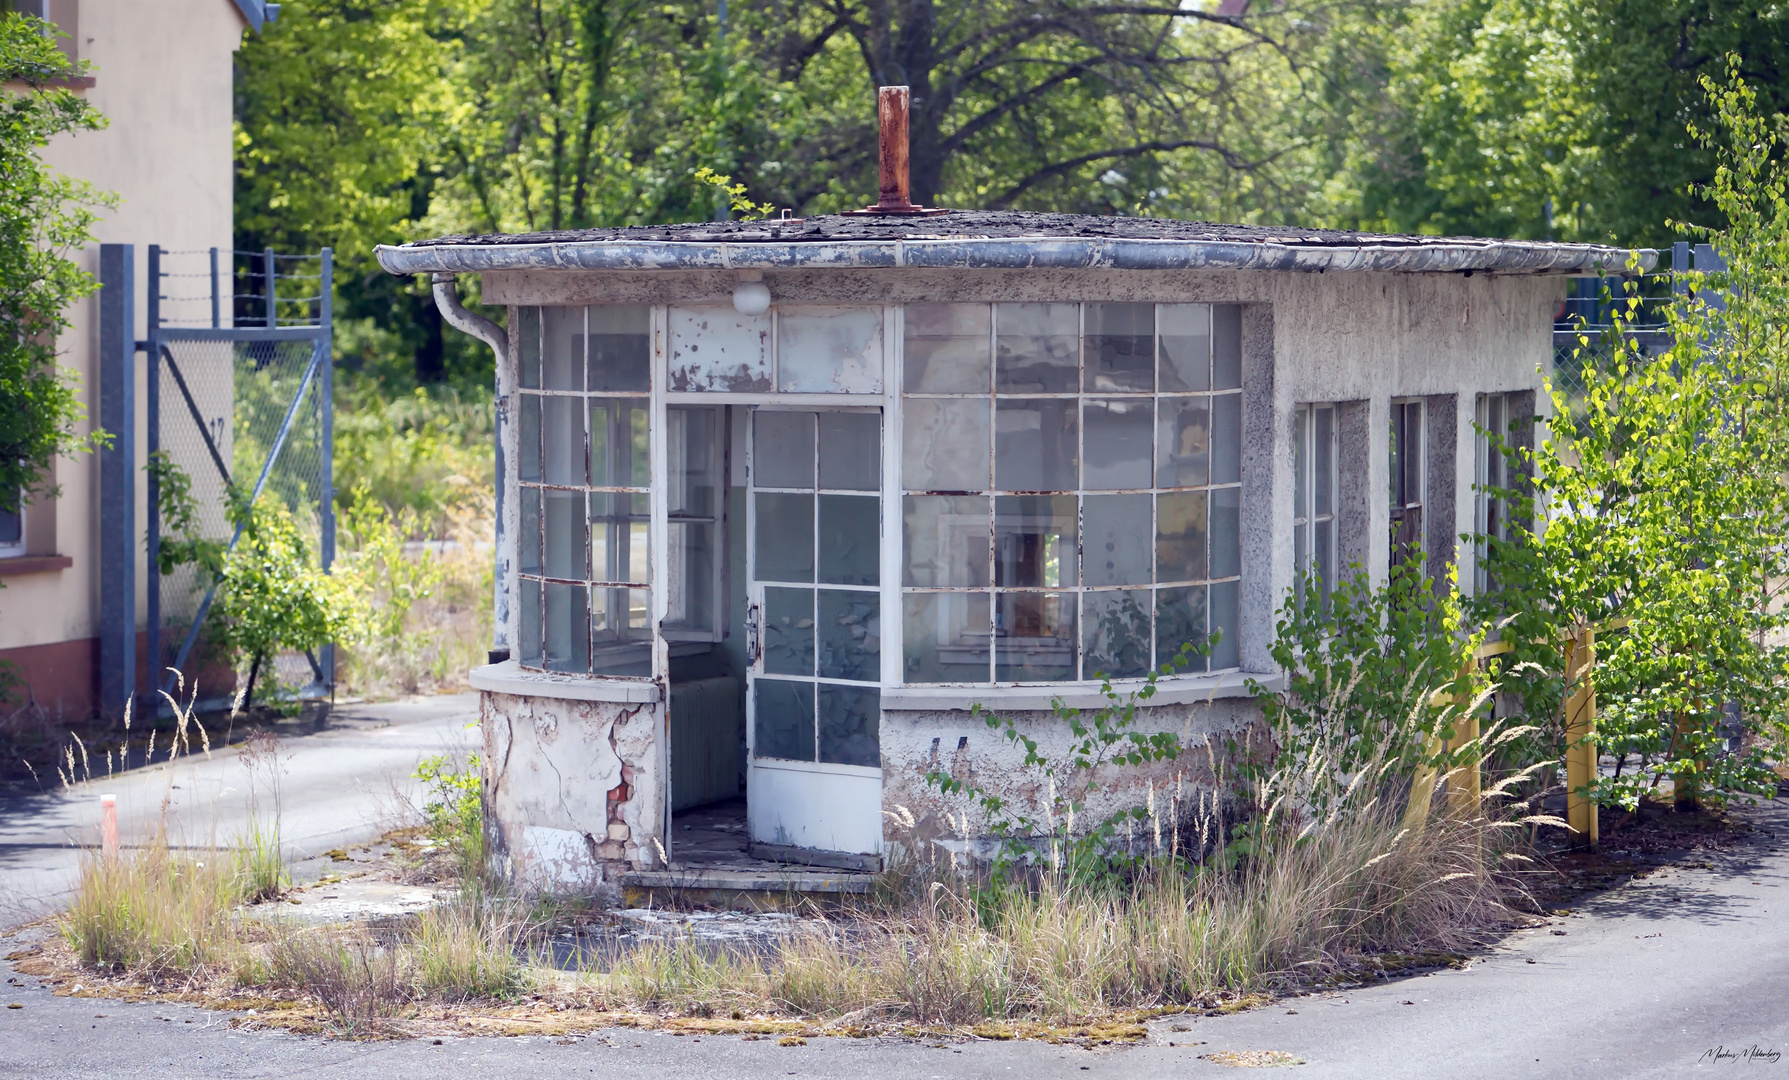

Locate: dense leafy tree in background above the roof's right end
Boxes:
[1336,0,1789,245]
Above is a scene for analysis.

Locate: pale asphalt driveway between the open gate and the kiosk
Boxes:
[0,694,478,926]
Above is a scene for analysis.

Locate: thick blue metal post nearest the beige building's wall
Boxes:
[98,243,138,717]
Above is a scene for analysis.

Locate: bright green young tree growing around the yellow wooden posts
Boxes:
[1478,65,1789,806]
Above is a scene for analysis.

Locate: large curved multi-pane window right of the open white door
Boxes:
[902,304,1242,683]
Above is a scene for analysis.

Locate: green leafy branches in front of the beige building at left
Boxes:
[0,11,111,513]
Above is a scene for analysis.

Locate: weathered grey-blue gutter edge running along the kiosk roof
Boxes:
[374,236,1658,275]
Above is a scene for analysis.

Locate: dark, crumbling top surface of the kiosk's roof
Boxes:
[410,209,1463,247]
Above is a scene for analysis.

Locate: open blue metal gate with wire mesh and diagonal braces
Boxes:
[140,245,335,697]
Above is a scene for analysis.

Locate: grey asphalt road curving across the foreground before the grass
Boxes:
[0,801,1789,1080]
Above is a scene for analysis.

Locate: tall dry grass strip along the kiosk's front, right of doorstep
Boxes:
[603,812,1512,1025]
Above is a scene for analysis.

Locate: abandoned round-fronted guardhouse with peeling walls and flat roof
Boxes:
[379,211,1651,883]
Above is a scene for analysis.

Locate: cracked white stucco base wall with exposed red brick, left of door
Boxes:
[479,692,666,890]
